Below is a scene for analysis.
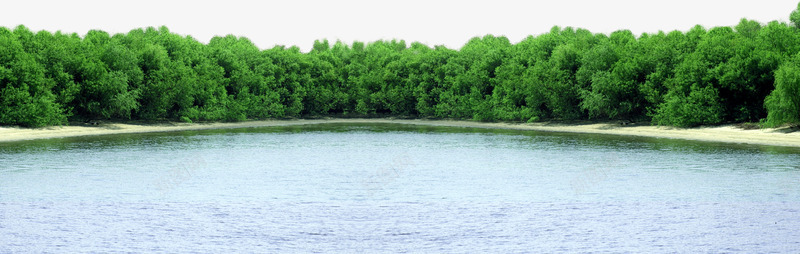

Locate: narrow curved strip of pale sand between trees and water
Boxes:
[0,119,800,147]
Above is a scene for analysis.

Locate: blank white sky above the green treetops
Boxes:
[0,0,798,51]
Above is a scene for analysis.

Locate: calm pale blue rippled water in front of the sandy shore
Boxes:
[0,124,800,253]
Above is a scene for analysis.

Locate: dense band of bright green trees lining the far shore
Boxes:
[0,6,800,127]
